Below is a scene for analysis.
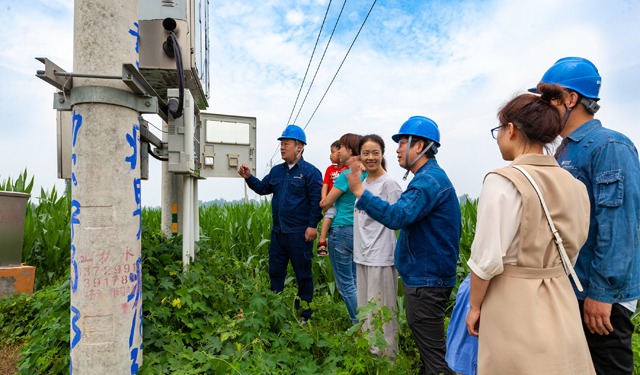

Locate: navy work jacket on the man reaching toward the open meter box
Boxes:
[246,158,322,233]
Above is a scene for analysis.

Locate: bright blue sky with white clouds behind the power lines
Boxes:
[0,0,640,206]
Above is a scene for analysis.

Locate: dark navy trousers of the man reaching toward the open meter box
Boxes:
[269,231,313,320]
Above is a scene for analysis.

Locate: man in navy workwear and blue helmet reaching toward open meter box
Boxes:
[238,125,322,322]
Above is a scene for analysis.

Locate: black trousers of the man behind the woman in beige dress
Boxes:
[578,300,635,375]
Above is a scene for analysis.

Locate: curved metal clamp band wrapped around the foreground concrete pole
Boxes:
[53,86,158,113]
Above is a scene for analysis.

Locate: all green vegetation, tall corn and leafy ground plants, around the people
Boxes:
[0,171,640,375]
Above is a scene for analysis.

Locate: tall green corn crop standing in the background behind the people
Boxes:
[0,170,477,302]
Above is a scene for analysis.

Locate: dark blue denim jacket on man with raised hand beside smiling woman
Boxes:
[356,159,462,288]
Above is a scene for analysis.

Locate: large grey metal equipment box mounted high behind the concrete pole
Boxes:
[138,0,209,110]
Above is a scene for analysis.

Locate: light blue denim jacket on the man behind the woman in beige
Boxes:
[556,120,640,303]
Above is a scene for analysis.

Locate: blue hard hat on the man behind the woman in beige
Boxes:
[529,57,602,100]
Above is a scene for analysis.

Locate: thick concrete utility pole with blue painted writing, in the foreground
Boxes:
[71,0,142,375]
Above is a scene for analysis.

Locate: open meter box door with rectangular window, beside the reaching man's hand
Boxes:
[198,113,257,178]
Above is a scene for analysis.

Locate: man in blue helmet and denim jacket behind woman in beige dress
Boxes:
[529,57,640,375]
